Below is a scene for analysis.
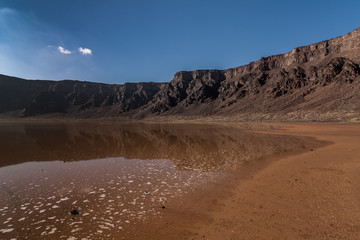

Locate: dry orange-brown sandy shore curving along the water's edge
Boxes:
[134,123,360,240]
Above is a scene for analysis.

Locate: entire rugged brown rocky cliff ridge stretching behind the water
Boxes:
[0,29,360,120]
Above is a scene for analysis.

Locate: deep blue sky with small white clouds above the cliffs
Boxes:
[0,0,360,84]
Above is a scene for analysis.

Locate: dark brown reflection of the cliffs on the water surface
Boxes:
[0,123,320,170]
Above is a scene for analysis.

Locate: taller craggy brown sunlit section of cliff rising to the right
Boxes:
[136,29,360,120]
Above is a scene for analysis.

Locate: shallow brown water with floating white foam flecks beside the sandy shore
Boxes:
[0,123,316,239]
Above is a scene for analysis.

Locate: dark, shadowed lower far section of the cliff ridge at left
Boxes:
[0,75,164,117]
